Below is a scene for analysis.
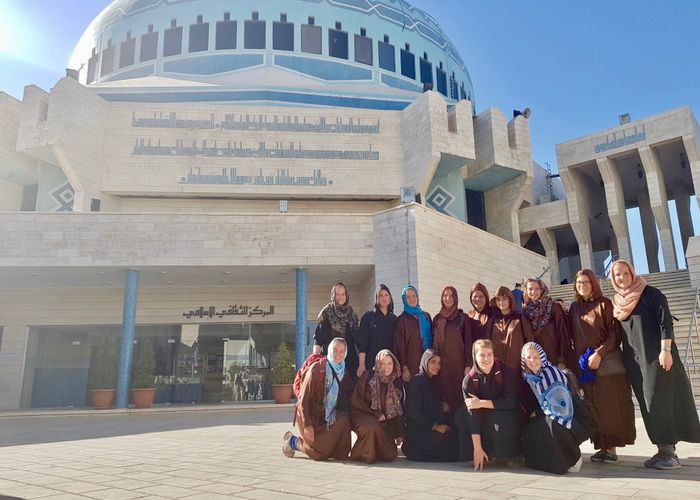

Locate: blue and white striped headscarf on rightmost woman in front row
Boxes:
[520,342,574,429]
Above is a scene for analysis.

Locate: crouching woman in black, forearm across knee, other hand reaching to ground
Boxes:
[455,339,520,470]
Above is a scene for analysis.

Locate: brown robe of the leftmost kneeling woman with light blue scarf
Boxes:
[296,361,354,460]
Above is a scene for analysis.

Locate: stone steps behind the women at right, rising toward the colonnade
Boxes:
[549,269,700,405]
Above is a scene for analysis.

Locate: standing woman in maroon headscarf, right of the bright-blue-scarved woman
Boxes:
[433,286,472,413]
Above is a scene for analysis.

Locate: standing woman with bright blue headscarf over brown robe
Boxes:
[394,285,433,384]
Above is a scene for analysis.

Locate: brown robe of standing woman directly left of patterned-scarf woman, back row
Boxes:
[487,311,535,374]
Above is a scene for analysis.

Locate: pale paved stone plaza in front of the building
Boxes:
[0,405,700,500]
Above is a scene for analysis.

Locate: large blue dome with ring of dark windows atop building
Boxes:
[71,0,474,109]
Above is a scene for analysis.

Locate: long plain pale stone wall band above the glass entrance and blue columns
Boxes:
[0,213,374,267]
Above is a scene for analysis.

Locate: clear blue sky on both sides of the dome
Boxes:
[0,0,700,272]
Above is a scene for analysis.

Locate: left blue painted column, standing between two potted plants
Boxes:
[114,269,139,408]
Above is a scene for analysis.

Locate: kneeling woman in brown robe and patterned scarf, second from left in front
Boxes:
[350,349,403,464]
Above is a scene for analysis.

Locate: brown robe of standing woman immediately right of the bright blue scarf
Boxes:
[433,310,472,412]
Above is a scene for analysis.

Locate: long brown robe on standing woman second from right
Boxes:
[569,297,636,449]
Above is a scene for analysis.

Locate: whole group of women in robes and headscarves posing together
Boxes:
[282,261,700,474]
